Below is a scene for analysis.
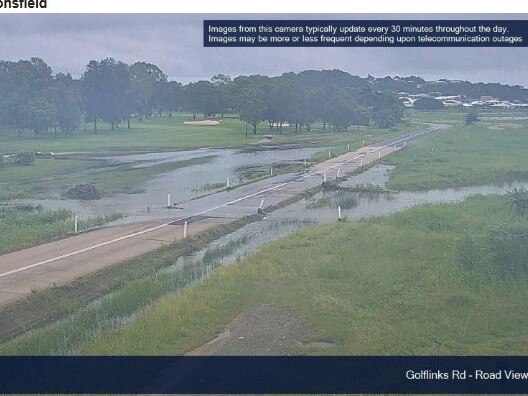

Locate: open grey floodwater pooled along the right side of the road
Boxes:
[167,165,528,276]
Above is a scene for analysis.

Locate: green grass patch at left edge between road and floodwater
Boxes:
[0,205,123,254]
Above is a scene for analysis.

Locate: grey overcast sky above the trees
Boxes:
[0,14,528,87]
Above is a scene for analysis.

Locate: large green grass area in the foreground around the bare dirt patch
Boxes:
[21,196,528,355]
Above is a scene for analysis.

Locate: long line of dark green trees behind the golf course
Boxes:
[5,58,496,136]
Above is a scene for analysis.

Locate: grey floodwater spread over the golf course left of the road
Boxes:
[15,147,327,223]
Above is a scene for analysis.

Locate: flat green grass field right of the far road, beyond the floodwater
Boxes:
[383,121,528,190]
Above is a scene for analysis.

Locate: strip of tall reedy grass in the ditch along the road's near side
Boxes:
[0,236,247,355]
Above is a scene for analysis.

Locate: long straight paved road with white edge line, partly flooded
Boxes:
[0,125,444,306]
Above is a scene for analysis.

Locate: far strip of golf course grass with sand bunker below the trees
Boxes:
[0,114,416,154]
